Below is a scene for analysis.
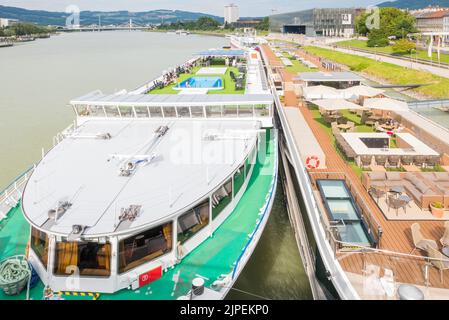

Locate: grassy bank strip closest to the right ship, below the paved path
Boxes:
[305,46,449,99]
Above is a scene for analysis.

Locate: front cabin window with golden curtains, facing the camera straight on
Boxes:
[54,241,111,277]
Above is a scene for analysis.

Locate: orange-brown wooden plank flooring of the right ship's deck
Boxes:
[262,46,449,288]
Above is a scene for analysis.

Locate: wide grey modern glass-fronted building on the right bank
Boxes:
[270,8,364,38]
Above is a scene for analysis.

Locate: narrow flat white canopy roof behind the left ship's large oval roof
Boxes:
[70,91,273,107]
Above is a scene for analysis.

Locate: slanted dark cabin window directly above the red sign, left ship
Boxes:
[119,222,173,273]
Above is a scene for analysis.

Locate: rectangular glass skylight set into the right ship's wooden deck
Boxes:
[317,180,375,247]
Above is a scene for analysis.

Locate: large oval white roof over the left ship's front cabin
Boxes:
[23,120,259,236]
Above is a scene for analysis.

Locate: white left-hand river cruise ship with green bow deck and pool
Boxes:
[0,39,278,300]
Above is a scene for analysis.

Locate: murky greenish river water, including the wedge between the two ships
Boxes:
[0,31,312,299]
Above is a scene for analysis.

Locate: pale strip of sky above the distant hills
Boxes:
[0,0,383,16]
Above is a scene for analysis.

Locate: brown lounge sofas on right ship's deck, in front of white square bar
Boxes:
[362,172,449,210]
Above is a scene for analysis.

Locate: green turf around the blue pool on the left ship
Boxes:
[150,65,245,94]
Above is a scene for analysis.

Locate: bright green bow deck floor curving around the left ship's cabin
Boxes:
[0,130,277,300]
